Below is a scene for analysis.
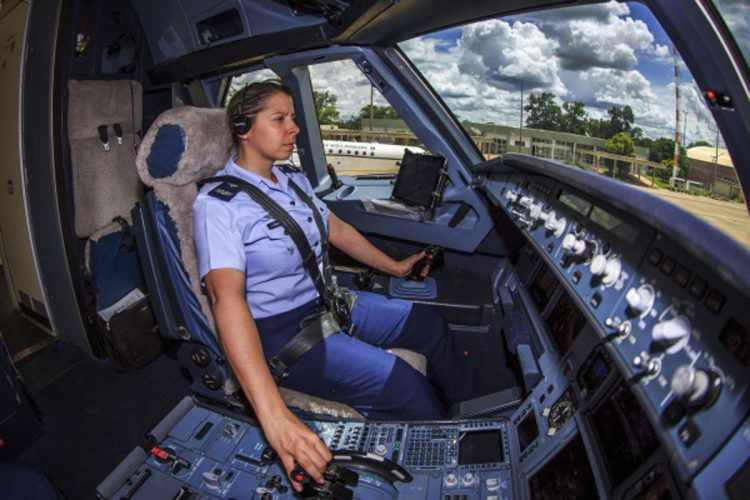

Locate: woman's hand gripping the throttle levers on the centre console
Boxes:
[263,408,333,491]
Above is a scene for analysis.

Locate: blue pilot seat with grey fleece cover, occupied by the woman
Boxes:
[132,106,426,419]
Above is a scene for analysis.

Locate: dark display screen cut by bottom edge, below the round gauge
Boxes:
[529,435,599,500]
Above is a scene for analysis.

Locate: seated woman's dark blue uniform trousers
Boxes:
[256,292,463,420]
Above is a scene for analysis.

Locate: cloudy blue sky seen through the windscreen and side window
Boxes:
[298,2,716,142]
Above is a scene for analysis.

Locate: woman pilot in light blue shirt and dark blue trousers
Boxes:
[193,81,482,488]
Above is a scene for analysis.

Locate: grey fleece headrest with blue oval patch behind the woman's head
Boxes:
[136,106,232,187]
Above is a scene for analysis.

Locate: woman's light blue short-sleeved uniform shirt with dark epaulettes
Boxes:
[193,159,328,318]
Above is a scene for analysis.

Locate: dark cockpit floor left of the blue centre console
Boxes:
[19,344,188,499]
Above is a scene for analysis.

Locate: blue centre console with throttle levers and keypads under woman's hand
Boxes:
[97,398,515,500]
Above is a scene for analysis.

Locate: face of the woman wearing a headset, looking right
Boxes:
[241,92,299,162]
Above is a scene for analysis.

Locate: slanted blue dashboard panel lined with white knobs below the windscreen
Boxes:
[483,174,750,488]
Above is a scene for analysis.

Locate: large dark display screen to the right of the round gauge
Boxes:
[591,383,659,486]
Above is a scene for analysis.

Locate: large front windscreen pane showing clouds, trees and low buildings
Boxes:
[399,0,750,247]
